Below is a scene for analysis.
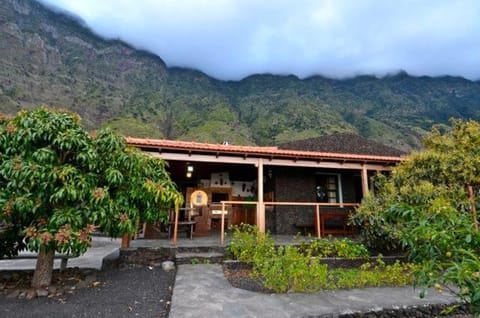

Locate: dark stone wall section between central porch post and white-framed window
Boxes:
[267,168,316,235]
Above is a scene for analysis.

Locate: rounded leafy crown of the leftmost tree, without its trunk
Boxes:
[0,108,98,254]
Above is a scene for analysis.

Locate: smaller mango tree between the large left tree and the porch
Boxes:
[95,129,183,247]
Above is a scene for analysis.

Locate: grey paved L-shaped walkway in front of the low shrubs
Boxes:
[169,264,455,318]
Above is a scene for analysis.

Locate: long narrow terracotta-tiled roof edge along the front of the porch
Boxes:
[126,137,402,163]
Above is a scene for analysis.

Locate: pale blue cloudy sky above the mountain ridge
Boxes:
[41,0,480,80]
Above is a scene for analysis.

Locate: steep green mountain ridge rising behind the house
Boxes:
[0,0,480,150]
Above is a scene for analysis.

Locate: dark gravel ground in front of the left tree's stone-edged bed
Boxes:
[0,267,175,318]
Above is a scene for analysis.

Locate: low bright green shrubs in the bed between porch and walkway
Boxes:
[229,224,414,293]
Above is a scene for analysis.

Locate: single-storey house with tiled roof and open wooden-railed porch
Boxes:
[127,134,404,239]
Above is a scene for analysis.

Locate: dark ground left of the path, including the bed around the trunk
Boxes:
[0,266,175,318]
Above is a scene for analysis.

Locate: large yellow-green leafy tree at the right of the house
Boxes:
[355,120,480,313]
